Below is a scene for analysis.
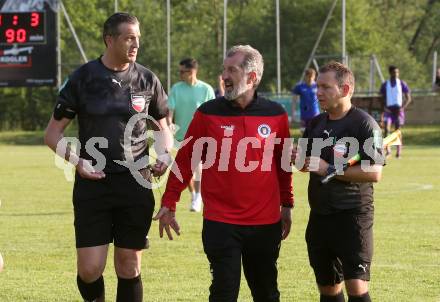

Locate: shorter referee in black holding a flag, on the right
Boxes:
[292,62,383,302]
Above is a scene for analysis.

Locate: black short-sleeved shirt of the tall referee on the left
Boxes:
[54,58,168,173]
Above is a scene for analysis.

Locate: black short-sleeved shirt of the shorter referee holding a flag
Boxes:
[303,107,384,215]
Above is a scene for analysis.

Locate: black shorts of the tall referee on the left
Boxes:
[73,172,154,250]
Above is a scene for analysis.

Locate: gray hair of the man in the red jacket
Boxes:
[226,45,264,87]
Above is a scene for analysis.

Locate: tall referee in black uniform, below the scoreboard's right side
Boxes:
[45,13,173,302]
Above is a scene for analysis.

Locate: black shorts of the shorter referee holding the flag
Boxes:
[306,210,373,286]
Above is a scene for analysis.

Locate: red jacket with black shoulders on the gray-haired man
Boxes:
[162,94,293,225]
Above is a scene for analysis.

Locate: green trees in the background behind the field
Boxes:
[0,0,440,130]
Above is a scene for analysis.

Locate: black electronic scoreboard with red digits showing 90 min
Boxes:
[0,0,57,87]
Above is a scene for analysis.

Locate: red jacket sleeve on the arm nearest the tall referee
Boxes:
[162,111,204,211]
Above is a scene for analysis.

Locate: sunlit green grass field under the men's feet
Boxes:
[0,126,440,302]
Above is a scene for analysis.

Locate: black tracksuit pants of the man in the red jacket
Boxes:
[202,219,281,302]
